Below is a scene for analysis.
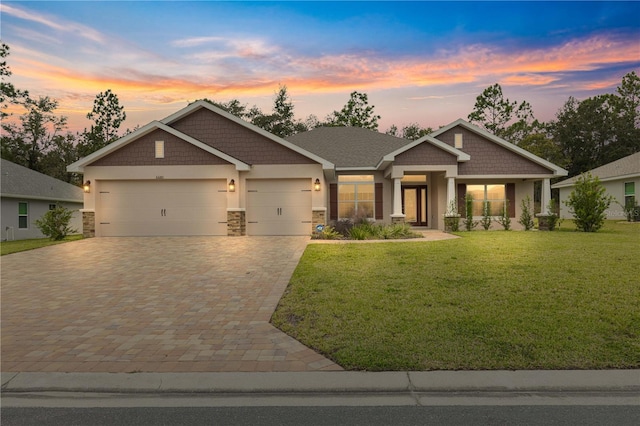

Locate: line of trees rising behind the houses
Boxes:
[0,42,640,185]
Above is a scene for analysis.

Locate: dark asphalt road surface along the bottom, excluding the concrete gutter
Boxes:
[1,405,640,426]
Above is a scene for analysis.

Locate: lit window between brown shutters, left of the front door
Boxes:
[338,175,375,219]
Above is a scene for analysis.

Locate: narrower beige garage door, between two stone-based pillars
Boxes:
[247,179,312,235]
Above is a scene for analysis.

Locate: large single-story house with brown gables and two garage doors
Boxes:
[68,101,567,236]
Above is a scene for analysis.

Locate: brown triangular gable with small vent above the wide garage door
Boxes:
[90,129,229,166]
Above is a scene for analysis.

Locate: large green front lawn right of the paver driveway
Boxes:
[272,221,640,371]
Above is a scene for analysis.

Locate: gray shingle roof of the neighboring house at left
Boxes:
[0,159,84,203]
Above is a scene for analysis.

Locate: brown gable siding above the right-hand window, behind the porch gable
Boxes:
[437,126,552,175]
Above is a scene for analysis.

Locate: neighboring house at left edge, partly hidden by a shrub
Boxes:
[0,159,83,241]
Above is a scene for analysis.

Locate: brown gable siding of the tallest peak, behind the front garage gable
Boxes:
[170,108,315,164]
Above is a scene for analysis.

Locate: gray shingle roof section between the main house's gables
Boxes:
[287,127,411,168]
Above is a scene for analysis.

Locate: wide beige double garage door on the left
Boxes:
[96,179,227,237]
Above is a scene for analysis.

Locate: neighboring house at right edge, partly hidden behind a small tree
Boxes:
[551,152,640,219]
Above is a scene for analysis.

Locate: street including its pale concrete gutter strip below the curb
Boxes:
[0,392,640,426]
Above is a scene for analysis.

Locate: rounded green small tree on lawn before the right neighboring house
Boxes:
[564,172,613,232]
